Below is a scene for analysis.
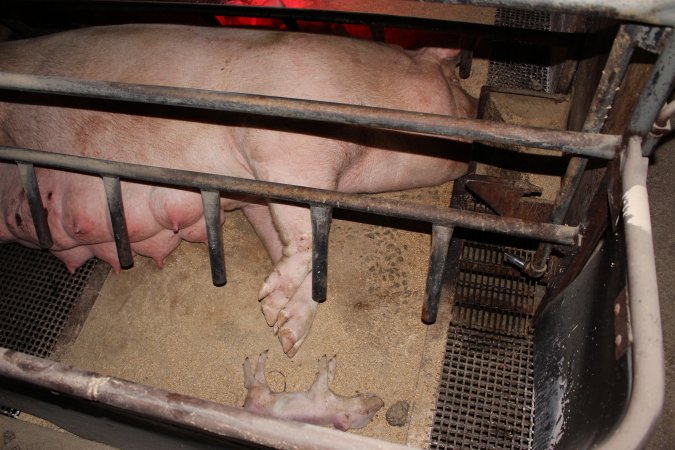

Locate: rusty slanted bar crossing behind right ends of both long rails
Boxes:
[525,25,647,277]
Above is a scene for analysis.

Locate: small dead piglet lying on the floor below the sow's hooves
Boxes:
[244,351,384,431]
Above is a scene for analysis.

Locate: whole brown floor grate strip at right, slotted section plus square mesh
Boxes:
[428,184,544,449]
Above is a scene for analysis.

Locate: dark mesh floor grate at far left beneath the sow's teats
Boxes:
[0,244,97,417]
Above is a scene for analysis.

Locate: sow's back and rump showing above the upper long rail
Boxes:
[0,24,452,112]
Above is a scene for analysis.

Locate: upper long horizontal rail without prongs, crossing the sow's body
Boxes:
[0,72,621,159]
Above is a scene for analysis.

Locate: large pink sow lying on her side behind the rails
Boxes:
[0,25,474,357]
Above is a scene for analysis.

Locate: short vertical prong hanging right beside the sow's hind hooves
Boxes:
[310,205,333,302]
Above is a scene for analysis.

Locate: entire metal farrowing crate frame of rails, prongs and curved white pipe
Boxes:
[0,0,675,448]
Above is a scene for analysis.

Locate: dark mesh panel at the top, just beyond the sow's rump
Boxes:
[487,8,551,92]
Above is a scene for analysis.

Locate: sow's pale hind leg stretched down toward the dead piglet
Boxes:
[242,132,345,357]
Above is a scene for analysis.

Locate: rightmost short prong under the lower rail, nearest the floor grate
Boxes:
[422,224,454,324]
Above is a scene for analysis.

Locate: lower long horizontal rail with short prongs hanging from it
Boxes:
[0,146,579,245]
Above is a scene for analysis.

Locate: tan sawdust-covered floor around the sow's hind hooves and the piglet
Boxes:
[60,183,451,443]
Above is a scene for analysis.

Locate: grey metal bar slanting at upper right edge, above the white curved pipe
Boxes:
[626,33,675,156]
